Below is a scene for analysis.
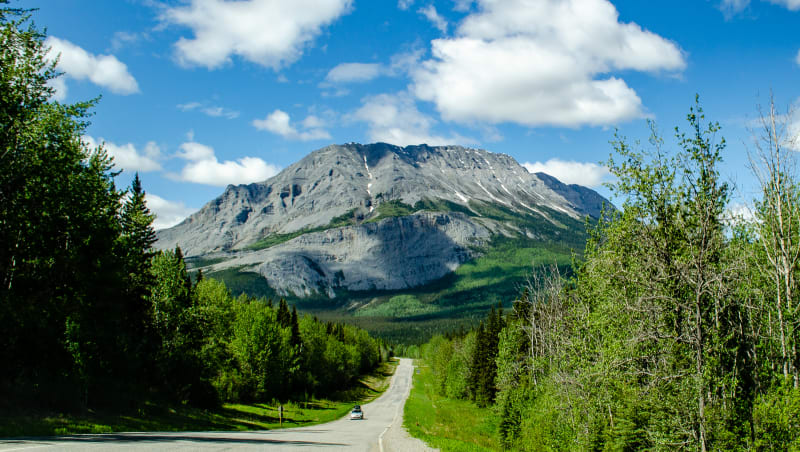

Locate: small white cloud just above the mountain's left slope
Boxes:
[169,141,280,186]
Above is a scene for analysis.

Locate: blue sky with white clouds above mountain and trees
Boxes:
[23,0,800,228]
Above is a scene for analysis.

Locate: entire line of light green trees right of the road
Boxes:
[422,98,800,451]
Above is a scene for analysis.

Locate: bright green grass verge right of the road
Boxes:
[403,366,500,452]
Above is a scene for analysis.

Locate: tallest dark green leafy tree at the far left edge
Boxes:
[0,2,133,404]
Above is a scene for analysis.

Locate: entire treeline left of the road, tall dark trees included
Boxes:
[0,7,387,408]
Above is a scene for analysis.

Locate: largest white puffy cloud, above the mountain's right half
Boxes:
[412,0,686,127]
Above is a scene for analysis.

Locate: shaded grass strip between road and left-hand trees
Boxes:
[0,361,397,438]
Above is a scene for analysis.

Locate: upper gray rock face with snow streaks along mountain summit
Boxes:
[157,143,604,256]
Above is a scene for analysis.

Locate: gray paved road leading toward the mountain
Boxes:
[0,359,413,452]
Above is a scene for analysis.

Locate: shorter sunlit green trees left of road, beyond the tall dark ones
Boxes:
[149,249,389,405]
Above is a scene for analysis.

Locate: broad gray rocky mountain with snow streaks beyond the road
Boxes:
[157,143,609,306]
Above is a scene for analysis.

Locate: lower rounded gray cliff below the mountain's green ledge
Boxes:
[205,212,490,297]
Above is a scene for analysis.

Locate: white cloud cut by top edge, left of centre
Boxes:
[162,0,352,70]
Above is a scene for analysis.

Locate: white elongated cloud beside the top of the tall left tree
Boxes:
[44,36,139,100]
